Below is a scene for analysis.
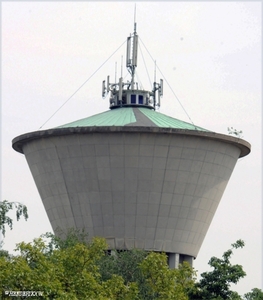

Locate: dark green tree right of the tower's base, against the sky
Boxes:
[191,240,246,300]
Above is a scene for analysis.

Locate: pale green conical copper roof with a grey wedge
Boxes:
[57,107,209,131]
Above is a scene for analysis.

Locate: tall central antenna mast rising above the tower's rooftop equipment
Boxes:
[126,6,138,90]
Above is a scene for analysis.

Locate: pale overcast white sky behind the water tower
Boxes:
[1,1,262,294]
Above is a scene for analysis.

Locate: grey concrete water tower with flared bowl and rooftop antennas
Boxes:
[13,25,250,267]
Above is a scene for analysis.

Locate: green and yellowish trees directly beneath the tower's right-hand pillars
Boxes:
[96,249,195,300]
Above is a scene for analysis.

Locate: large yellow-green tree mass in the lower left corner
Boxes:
[0,238,138,300]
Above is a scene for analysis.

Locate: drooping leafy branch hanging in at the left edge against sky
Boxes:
[0,200,28,236]
